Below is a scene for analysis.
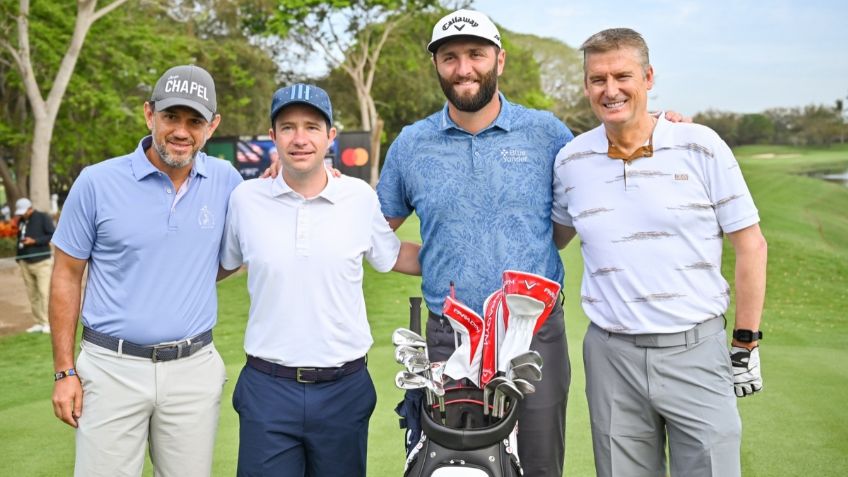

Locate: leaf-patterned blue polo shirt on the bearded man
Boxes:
[377,95,574,314]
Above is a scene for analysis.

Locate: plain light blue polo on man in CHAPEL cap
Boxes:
[53,136,242,345]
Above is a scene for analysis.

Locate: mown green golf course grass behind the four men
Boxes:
[0,146,848,477]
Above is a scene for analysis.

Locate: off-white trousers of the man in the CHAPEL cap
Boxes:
[74,341,227,477]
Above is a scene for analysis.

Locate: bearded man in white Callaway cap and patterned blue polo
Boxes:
[377,10,573,477]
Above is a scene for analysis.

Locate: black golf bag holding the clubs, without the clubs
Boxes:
[403,387,523,477]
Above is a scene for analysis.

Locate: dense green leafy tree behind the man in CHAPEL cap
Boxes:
[0,0,278,201]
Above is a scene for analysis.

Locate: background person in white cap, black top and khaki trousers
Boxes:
[15,197,55,334]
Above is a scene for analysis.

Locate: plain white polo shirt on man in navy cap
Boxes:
[221,174,400,367]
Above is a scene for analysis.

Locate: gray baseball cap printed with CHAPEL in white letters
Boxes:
[150,65,218,121]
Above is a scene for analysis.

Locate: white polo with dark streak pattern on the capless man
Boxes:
[552,114,759,334]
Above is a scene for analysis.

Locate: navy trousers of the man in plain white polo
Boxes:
[233,360,377,477]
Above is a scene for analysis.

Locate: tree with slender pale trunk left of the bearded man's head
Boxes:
[246,0,437,187]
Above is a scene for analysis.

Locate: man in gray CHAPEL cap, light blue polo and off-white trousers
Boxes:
[50,65,241,476]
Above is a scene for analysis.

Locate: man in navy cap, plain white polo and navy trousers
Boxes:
[221,84,420,477]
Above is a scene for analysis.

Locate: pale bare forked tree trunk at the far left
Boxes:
[0,0,127,210]
